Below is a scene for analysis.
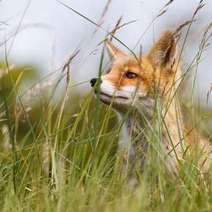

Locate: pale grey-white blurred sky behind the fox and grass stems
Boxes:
[0,0,212,107]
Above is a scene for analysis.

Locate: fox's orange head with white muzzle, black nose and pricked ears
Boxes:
[91,31,179,111]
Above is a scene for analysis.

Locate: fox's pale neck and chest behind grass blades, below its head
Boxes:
[118,92,184,172]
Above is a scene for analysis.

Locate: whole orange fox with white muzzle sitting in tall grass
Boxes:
[90,31,212,175]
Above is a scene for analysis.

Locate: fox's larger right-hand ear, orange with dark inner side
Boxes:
[148,31,176,68]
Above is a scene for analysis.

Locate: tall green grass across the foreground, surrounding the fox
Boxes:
[0,1,212,212]
